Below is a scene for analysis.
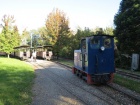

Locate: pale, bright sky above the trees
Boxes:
[0,0,121,32]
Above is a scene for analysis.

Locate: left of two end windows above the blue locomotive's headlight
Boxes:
[90,37,100,49]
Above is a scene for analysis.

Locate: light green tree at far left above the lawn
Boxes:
[0,15,20,58]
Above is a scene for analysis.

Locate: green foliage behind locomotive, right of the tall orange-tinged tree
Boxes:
[54,27,113,59]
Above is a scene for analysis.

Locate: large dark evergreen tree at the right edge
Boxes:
[114,0,140,54]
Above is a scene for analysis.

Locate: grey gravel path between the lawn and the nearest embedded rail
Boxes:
[32,61,85,105]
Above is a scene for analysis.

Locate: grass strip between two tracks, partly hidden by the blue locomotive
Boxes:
[55,60,140,93]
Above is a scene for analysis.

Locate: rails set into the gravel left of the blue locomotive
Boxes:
[30,63,120,105]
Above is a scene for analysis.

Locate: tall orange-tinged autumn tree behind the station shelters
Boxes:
[46,9,71,58]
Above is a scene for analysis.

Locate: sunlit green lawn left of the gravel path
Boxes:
[0,57,35,105]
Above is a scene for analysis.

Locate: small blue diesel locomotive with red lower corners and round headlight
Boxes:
[72,35,115,84]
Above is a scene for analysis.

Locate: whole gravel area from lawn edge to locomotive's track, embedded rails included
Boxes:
[27,60,139,105]
